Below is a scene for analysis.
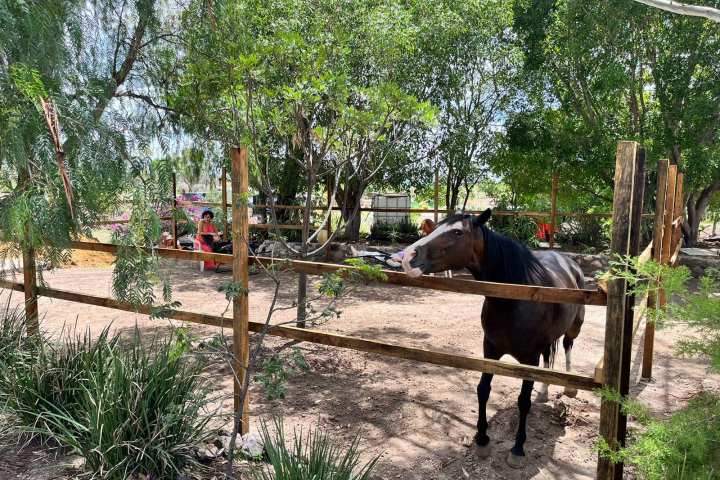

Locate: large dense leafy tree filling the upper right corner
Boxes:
[514,0,720,245]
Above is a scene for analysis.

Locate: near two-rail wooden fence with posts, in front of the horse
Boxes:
[0,142,682,480]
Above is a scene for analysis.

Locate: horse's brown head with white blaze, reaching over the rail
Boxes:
[402,208,491,277]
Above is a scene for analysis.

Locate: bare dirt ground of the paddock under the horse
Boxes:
[0,262,720,480]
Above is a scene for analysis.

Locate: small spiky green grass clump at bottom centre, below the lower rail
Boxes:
[253,418,380,480]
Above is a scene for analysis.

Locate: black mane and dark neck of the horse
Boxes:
[439,213,548,285]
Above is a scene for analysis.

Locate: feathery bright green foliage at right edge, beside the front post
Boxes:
[599,258,720,480]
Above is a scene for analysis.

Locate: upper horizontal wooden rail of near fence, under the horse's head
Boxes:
[71,242,607,305]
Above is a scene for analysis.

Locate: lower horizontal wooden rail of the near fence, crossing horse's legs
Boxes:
[0,282,600,390]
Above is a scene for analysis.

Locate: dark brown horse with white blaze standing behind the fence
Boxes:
[398,209,585,468]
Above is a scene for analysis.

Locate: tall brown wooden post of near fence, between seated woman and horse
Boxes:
[230,148,250,434]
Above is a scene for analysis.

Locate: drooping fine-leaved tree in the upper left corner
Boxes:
[0,0,177,274]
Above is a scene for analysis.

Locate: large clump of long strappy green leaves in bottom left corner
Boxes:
[0,328,210,479]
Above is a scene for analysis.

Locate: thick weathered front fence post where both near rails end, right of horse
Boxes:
[597,141,639,480]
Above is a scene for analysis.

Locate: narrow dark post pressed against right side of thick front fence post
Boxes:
[615,147,645,480]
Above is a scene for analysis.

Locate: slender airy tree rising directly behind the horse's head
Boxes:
[396,0,522,210]
